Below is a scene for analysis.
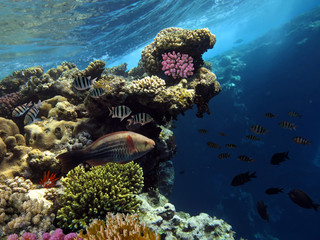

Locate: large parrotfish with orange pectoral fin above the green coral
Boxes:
[57,131,155,173]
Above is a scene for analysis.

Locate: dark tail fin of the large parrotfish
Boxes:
[57,150,85,173]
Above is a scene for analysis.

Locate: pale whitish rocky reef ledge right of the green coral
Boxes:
[139,190,234,240]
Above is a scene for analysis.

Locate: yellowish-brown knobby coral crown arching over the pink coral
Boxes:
[141,27,216,75]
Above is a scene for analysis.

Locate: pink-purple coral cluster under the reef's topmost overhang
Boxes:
[162,51,194,79]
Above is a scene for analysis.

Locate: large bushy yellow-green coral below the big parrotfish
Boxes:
[57,162,143,231]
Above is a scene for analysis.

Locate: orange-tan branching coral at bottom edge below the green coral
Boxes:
[78,213,160,240]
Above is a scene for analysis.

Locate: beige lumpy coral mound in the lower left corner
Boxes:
[0,177,54,235]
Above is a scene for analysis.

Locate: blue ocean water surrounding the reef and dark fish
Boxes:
[0,0,320,240]
